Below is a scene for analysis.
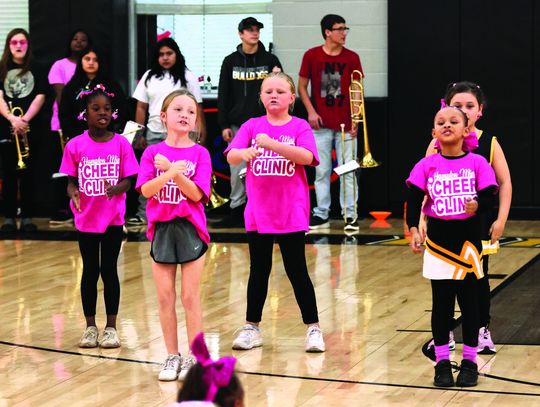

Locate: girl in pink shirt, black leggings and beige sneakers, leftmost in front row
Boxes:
[60,85,138,348]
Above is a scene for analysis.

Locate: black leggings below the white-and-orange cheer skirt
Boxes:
[431,273,480,347]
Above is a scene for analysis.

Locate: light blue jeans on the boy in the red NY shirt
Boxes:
[313,128,358,219]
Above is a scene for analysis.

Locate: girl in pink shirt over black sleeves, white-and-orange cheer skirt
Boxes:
[407,107,497,387]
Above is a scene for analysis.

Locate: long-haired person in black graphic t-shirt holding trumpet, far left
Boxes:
[0,28,47,232]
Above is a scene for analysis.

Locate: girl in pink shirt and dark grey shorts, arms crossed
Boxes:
[137,89,212,381]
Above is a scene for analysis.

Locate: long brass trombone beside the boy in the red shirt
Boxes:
[349,70,381,168]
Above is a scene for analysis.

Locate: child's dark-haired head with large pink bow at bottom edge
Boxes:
[178,332,244,407]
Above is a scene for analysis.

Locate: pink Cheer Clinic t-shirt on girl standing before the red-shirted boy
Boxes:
[225,116,319,233]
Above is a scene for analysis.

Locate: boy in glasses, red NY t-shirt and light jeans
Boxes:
[298,14,364,232]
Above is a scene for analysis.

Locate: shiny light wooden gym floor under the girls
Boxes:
[0,219,540,407]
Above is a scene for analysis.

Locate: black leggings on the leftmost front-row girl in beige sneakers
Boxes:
[79,226,122,317]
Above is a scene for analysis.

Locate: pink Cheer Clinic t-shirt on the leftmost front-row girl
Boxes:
[60,131,138,233]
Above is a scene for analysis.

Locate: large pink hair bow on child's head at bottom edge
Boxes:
[191,332,236,401]
